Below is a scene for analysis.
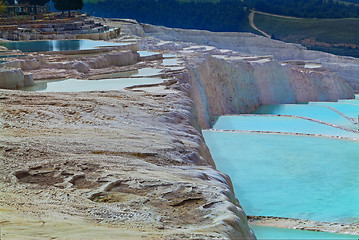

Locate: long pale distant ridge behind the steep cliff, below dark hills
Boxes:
[134,24,359,91]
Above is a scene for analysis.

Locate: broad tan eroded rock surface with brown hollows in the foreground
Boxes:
[0,87,253,239]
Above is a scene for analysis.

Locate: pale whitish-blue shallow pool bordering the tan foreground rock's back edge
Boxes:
[22,78,163,92]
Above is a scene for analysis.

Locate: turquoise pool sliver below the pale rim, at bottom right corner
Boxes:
[250,225,359,240]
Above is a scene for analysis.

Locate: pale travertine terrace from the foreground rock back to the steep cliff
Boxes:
[0,16,353,239]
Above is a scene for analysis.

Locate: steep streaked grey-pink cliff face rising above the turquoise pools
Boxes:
[187,56,354,128]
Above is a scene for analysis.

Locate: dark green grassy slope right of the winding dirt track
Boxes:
[254,13,359,57]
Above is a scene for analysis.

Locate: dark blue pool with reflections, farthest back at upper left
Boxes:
[0,39,126,52]
